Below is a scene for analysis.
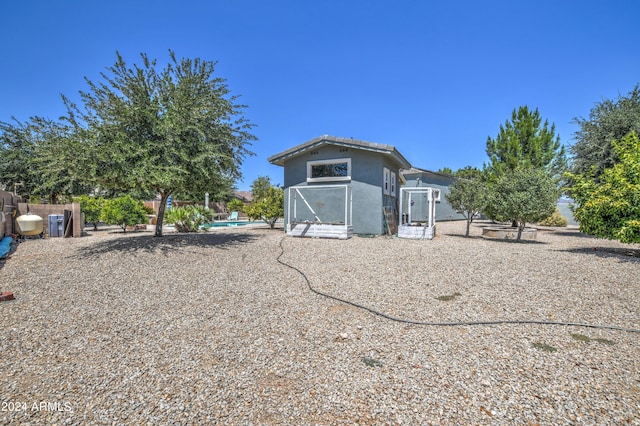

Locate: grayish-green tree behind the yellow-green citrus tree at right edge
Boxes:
[570,84,640,180]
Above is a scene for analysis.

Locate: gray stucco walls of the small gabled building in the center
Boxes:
[284,144,400,234]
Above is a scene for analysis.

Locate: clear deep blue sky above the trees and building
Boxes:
[0,0,640,189]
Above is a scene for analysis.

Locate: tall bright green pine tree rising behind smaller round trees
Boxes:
[485,106,567,179]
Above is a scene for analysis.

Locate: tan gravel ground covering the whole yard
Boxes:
[0,222,640,425]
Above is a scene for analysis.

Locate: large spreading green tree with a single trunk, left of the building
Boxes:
[64,51,256,236]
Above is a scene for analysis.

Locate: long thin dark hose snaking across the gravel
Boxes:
[276,237,640,333]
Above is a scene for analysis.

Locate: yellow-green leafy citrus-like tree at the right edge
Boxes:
[569,132,640,243]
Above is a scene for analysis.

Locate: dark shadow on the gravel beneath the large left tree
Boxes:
[70,232,259,259]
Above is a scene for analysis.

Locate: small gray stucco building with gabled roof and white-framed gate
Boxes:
[269,135,411,238]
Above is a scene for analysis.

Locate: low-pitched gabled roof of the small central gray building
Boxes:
[268,135,411,169]
